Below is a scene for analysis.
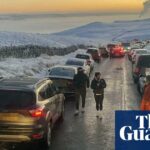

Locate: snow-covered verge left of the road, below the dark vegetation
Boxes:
[0,49,84,78]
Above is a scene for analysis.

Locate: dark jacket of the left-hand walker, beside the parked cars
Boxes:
[73,72,90,89]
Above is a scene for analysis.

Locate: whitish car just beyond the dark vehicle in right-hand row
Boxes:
[131,49,148,62]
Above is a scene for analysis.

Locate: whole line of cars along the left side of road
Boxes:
[0,48,109,148]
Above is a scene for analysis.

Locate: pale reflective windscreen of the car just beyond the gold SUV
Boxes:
[50,67,75,77]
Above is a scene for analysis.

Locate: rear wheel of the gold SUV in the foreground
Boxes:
[39,123,52,148]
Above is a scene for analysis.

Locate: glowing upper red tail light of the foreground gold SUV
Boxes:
[29,108,45,118]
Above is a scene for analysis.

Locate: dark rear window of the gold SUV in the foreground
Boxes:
[0,90,36,109]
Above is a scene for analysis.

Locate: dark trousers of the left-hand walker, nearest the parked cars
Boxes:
[76,89,86,110]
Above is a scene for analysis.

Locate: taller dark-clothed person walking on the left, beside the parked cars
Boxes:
[73,67,90,116]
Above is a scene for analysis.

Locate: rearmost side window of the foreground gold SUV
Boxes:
[38,84,54,101]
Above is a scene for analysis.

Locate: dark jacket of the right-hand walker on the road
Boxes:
[91,78,107,94]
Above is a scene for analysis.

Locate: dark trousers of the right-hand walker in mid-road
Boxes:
[94,94,104,111]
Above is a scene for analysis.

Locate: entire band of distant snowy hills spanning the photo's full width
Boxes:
[0,19,150,47]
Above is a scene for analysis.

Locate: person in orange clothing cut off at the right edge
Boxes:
[141,75,150,111]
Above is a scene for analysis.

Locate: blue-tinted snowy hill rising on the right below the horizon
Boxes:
[55,19,150,44]
